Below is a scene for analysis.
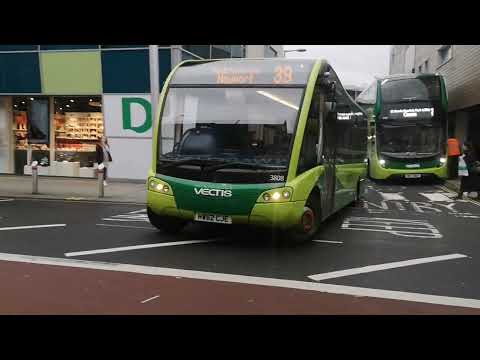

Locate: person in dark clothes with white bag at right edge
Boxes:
[457,141,480,199]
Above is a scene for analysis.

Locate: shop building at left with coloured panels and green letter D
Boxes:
[0,45,283,180]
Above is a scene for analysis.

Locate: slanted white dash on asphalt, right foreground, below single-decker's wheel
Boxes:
[308,254,467,281]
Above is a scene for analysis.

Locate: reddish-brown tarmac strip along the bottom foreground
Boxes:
[0,261,480,315]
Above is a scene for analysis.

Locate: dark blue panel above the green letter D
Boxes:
[102,50,150,94]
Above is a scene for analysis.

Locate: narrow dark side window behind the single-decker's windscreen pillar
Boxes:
[297,87,320,175]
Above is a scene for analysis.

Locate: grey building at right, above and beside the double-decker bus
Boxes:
[390,45,480,146]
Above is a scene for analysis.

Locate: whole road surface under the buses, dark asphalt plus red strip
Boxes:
[0,183,480,314]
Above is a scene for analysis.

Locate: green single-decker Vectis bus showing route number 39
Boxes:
[147,58,367,241]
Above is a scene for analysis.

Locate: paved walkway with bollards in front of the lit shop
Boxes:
[0,175,146,204]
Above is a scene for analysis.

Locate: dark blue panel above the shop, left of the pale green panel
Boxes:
[0,53,42,94]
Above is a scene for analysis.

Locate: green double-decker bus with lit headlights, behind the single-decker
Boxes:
[356,74,448,180]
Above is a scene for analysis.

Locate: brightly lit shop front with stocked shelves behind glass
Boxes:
[6,95,104,178]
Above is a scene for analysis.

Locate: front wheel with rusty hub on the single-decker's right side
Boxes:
[288,195,320,244]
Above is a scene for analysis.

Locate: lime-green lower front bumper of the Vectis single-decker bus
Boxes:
[147,190,305,228]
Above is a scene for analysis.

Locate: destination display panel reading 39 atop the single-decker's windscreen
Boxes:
[170,58,319,86]
